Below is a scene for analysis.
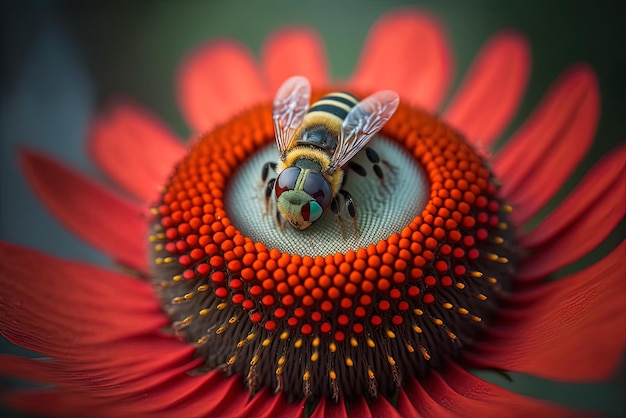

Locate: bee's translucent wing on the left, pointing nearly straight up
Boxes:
[272,76,311,159]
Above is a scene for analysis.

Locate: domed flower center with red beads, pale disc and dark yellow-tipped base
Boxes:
[150,94,516,400]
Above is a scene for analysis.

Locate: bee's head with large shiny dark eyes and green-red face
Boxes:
[274,167,332,230]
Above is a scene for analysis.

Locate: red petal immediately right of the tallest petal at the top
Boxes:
[444,32,530,148]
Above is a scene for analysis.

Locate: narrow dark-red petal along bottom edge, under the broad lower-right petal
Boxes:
[426,364,585,418]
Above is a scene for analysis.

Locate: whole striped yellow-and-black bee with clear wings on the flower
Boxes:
[262,76,400,230]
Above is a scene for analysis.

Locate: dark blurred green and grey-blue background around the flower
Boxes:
[0,0,626,417]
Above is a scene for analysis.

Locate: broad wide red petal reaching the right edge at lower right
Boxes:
[468,241,626,381]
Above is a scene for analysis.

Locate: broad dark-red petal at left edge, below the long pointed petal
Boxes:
[0,242,168,361]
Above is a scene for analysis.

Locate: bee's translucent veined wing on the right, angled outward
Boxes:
[328,90,400,173]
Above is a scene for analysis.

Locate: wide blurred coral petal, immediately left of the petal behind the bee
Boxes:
[178,40,269,132]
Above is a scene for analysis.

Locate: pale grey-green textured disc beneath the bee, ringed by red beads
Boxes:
[225,137,430,256]
